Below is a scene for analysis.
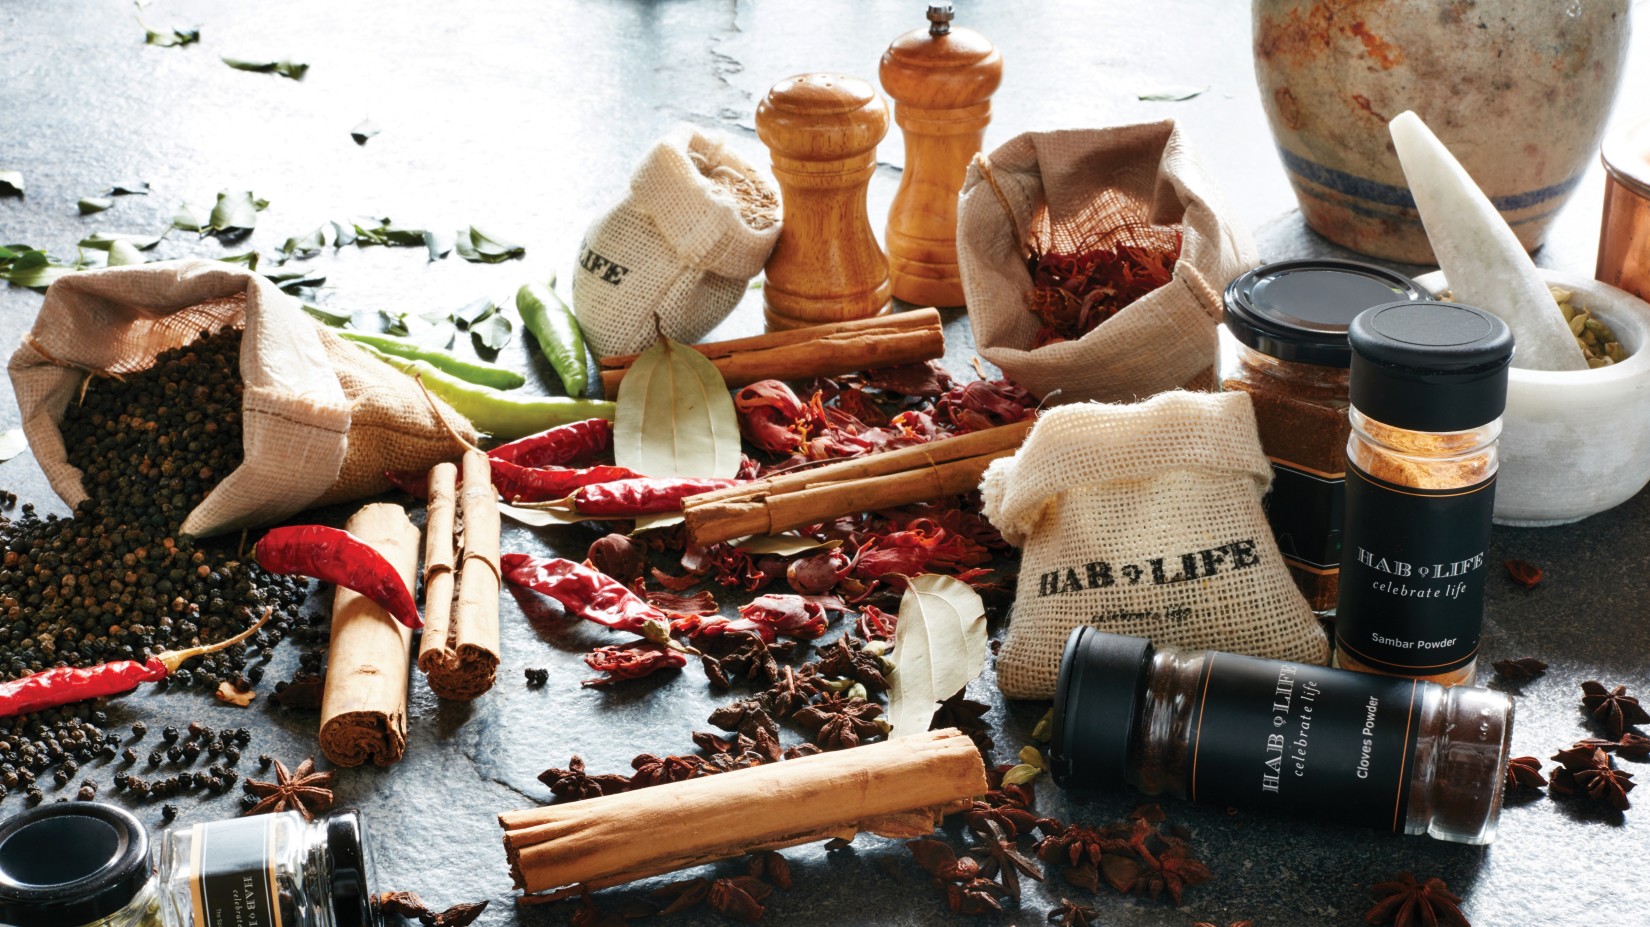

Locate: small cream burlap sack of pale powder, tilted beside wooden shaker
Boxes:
[573,125,779,356]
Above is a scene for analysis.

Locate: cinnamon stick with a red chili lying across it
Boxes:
[320,503,419,765]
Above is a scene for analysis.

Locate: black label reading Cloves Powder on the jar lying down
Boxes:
[1188,653,1422,833]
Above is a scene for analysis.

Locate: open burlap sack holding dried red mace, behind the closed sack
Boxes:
[957,120,1257,402]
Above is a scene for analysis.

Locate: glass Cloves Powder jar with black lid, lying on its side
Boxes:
[1049,627,1513,845]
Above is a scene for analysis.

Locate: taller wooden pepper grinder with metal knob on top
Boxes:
[881,2,1003,305]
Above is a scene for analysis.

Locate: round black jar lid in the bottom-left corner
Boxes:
[0,802,152,927]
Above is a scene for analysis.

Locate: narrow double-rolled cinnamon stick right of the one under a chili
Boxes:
[417,450,498,701]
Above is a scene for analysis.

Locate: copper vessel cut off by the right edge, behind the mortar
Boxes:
[1594,119,1650,300]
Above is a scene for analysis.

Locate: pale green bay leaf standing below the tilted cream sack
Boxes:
[614,336,741,477]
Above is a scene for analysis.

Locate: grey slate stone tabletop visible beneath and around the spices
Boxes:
[0,0,1650,927]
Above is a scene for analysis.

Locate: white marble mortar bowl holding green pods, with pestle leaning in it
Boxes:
[1416,267,1650,528]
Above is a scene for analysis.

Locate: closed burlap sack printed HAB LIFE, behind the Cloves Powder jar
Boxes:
[980,389,1330,698]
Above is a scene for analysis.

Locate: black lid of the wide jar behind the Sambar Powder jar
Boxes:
[1226,261,1427,368]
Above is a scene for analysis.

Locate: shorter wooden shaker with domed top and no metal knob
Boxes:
[756,74,888,330]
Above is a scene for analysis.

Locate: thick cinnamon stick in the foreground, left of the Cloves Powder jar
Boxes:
[498,727,987,894]
